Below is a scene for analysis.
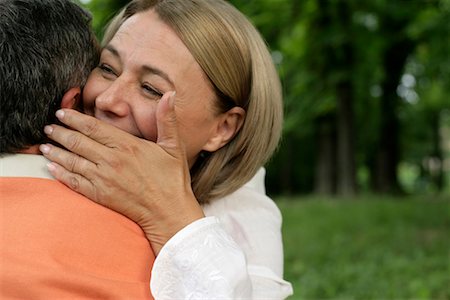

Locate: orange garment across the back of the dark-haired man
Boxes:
[0,177,155,300]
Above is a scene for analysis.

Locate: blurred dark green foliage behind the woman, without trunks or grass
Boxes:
[81,0,450,194]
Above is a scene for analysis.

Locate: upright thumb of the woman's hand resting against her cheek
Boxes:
[156,92,185,158]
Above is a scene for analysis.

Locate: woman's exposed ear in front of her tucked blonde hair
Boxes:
[203,106,245,152]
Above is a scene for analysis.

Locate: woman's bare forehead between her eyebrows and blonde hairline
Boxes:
[104,10,216,100]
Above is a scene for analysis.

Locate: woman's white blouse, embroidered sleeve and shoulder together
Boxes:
[151,187,292,300]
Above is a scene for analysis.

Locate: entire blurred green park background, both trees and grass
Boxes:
[81,0,450,299]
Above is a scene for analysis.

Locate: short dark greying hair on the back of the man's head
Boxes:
[0,0,99,153]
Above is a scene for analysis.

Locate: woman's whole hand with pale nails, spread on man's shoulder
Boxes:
[40,93,204,255]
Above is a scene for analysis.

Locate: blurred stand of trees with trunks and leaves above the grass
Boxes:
[81,0,450,195]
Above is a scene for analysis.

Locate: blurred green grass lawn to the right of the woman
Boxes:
[277,197,450,299]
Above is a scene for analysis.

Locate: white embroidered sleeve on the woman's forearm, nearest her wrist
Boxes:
[150,217,251,300]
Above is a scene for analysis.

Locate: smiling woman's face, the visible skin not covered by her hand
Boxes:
[83,10,220,165]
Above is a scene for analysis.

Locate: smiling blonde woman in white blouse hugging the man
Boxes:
[41,0,292,299]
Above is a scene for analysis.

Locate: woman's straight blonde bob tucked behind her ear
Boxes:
[103,0,283,203]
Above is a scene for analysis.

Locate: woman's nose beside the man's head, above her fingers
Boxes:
[95,79,130,117]
